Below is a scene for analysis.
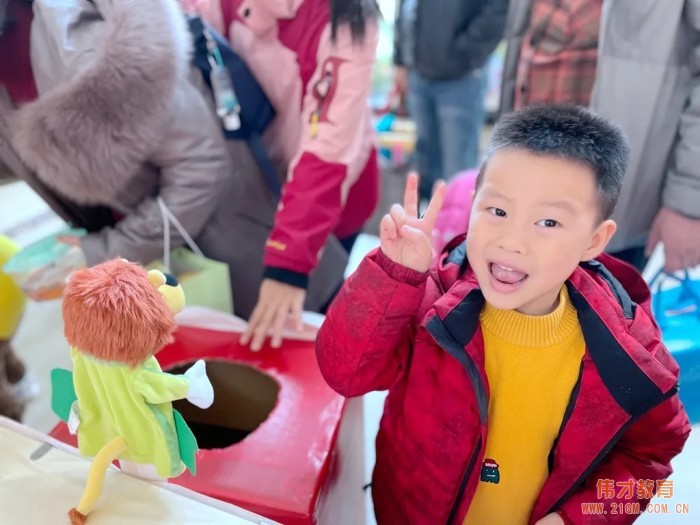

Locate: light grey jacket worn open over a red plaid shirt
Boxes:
[591,0,700,251]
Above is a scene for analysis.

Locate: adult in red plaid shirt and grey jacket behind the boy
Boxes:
[501,0,700,272]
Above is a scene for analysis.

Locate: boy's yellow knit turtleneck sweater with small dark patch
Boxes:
[464,287,585,525]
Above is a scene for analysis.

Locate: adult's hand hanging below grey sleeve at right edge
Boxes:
[646,208,700,273]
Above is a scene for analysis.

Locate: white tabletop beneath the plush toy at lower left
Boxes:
[0,417,277,525]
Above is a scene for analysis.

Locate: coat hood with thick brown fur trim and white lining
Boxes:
[10,0,191,205]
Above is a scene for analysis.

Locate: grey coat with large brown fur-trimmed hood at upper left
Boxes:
[0,0,233,263]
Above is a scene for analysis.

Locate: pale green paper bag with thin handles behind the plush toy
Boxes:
[147,197,233,314]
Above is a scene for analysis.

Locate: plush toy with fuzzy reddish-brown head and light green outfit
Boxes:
[51,259,214,524]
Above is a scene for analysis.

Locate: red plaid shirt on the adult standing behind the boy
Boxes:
[515,0,603,109]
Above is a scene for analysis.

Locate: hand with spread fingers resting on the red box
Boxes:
[241,279,306,352]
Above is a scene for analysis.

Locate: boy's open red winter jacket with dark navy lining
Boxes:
[317,237,690,525]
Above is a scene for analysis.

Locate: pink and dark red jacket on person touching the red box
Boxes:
[194,0,379,287]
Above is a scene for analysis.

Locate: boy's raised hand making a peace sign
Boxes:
[379,173,445,272]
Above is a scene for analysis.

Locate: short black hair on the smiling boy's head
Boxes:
[476,105,629,220]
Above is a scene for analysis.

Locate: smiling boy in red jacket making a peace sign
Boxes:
[317,106,690,525]
